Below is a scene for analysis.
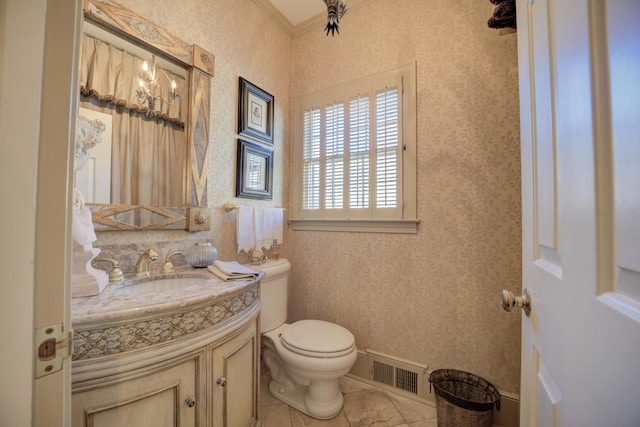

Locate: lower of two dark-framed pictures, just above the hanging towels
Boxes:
[236,139,273,200]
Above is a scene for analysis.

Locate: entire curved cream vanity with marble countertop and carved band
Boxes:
[72,268,261,427]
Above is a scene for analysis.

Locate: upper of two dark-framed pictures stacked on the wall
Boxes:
[238,77,274,145]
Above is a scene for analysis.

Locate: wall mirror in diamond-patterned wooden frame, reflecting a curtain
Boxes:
[76,0,214,231]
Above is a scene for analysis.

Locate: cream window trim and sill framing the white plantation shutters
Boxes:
[289,63,420,234]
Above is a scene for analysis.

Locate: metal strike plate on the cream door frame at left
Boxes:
[36,323,73,378]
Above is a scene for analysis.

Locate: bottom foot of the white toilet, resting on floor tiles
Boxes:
[269,379,344,420]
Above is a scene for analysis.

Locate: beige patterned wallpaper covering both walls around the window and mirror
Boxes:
[95,0,521,393]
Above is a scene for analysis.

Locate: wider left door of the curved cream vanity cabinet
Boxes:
[72,350,205,427]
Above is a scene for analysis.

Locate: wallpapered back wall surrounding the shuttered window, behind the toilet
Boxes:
[285,0,521,393]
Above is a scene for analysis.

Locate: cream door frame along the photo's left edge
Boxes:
[0,0,81,427]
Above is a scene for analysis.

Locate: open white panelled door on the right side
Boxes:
[517,0,640,427]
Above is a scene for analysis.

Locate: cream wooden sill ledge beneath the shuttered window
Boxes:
[289,219,420,234]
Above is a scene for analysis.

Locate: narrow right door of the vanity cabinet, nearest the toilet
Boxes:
[210,320,259,427]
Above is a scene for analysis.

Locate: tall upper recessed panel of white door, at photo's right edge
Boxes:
[608,0,640,302]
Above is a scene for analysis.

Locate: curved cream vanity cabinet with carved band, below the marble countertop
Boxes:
[71,280,261,427]
